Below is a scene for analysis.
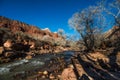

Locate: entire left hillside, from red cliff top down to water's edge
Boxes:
[0,16,65,62]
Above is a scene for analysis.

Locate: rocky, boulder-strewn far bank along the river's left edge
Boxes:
[0,44,71,64]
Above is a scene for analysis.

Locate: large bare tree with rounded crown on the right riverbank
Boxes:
[68,6,105,50]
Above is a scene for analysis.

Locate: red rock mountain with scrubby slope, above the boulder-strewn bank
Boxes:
[0,16,66,52]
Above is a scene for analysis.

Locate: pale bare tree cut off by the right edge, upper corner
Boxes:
[105,0,120,38]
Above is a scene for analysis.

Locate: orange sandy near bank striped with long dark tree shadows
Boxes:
[61,49,120,80]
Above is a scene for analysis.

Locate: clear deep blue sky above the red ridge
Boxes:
[0,0,113,34]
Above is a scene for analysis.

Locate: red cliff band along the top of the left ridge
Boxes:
[0,16,58,39]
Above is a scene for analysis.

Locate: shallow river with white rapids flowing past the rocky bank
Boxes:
[0,51,74,80]
